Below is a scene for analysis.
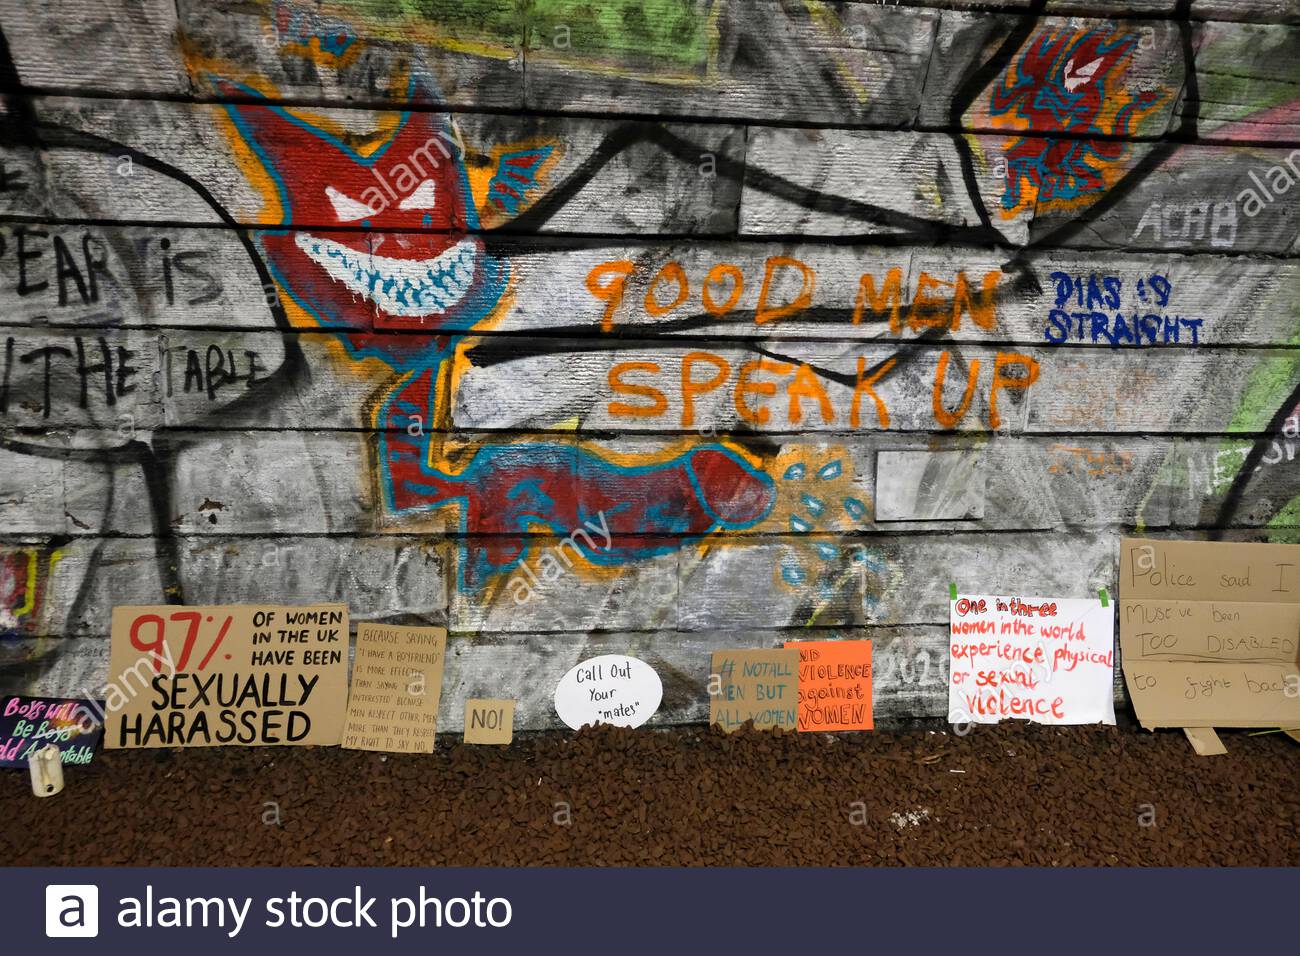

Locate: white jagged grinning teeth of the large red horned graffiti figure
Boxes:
[295,233,478,316]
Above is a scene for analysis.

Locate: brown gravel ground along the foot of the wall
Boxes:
[0,723,1300,866]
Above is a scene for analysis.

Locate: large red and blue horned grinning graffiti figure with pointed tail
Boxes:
[215,81,776,591]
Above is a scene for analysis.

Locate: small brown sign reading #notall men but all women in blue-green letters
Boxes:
[709,648,800,731]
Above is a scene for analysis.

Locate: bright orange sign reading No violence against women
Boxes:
[785,641,874,731]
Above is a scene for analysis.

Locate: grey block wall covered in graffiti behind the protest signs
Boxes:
[0,0,1300,728]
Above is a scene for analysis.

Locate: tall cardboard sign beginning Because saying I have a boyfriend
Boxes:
[343,624,447,753]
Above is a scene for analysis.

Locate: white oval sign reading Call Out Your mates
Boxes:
[555,654,663,730]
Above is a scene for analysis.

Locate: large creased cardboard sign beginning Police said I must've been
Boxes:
[1119,538,1300,728]
